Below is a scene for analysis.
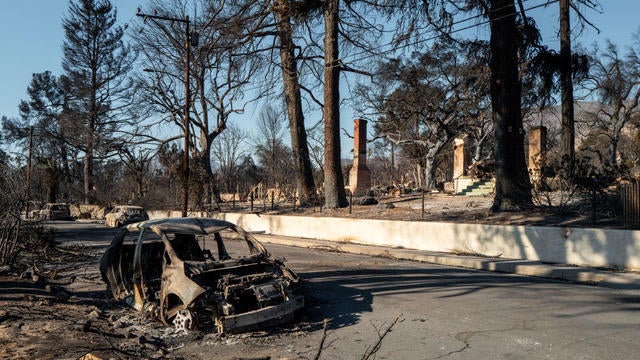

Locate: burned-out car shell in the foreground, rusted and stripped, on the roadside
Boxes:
[100,218,304,333]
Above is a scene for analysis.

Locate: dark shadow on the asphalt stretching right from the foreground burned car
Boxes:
[300,268,584,329]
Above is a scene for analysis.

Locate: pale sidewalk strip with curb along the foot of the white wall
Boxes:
[254,234,640,290]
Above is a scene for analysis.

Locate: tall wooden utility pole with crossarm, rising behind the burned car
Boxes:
[136,9,192,217]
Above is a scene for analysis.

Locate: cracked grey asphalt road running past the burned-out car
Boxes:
[54,222,640,359]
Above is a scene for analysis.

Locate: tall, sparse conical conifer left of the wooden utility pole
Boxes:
[62,0,135,203]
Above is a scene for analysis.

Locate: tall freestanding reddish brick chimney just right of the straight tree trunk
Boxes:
[348,119,371,196]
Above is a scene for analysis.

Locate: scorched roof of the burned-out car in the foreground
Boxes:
[127,217,237,235]
